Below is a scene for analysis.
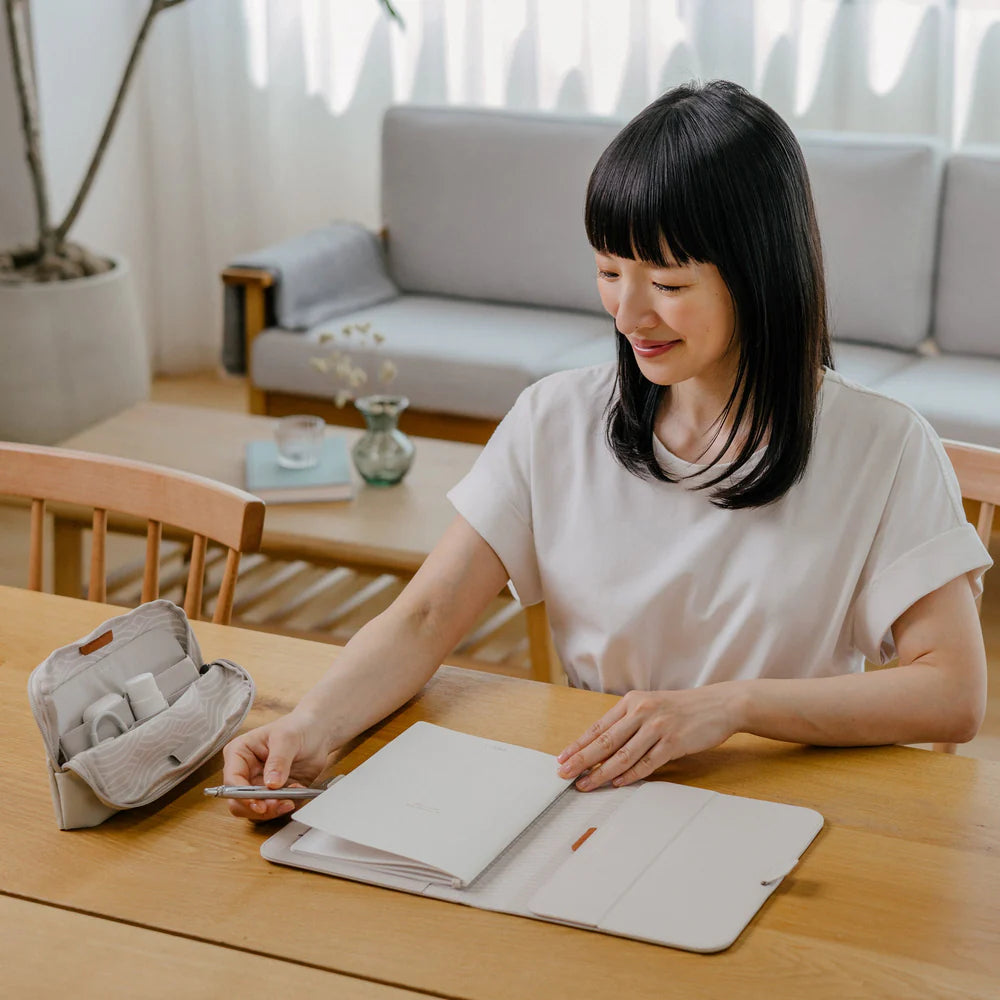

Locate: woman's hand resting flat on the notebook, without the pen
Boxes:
[558,683,739,791]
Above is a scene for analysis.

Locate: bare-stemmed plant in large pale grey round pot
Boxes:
[0,0,194,444]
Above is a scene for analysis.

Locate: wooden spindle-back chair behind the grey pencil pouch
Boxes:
[0,442,264,624]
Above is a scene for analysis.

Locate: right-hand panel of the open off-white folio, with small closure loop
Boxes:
[529,782,823,952]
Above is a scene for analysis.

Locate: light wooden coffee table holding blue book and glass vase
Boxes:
[53,402,554,680]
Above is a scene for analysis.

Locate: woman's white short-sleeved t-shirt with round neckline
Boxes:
[448,364,991,694]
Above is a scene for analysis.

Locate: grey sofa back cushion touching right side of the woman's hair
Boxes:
[799,133,943,349]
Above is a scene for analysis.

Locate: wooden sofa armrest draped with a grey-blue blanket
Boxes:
[222,222,399,390]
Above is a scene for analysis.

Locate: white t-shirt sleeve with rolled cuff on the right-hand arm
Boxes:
[853,419,992,663]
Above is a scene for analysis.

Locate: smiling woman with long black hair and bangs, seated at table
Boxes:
[225,81,990,819]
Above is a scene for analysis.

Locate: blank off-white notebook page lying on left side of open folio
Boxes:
[295,722,570,885]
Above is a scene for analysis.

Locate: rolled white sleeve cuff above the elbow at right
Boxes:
[854,524,993,663]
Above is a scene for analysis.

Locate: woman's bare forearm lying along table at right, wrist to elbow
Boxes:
[731,662,985,746]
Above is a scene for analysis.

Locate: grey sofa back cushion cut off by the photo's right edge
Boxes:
[934,152,1000,360]
